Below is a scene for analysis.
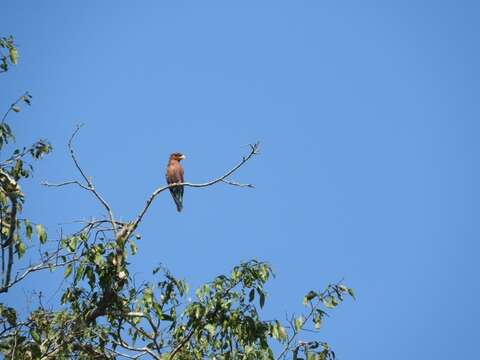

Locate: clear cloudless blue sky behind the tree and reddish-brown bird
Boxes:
[0,1,480,359]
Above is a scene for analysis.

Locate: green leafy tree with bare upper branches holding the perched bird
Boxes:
[0,34,354,360]
